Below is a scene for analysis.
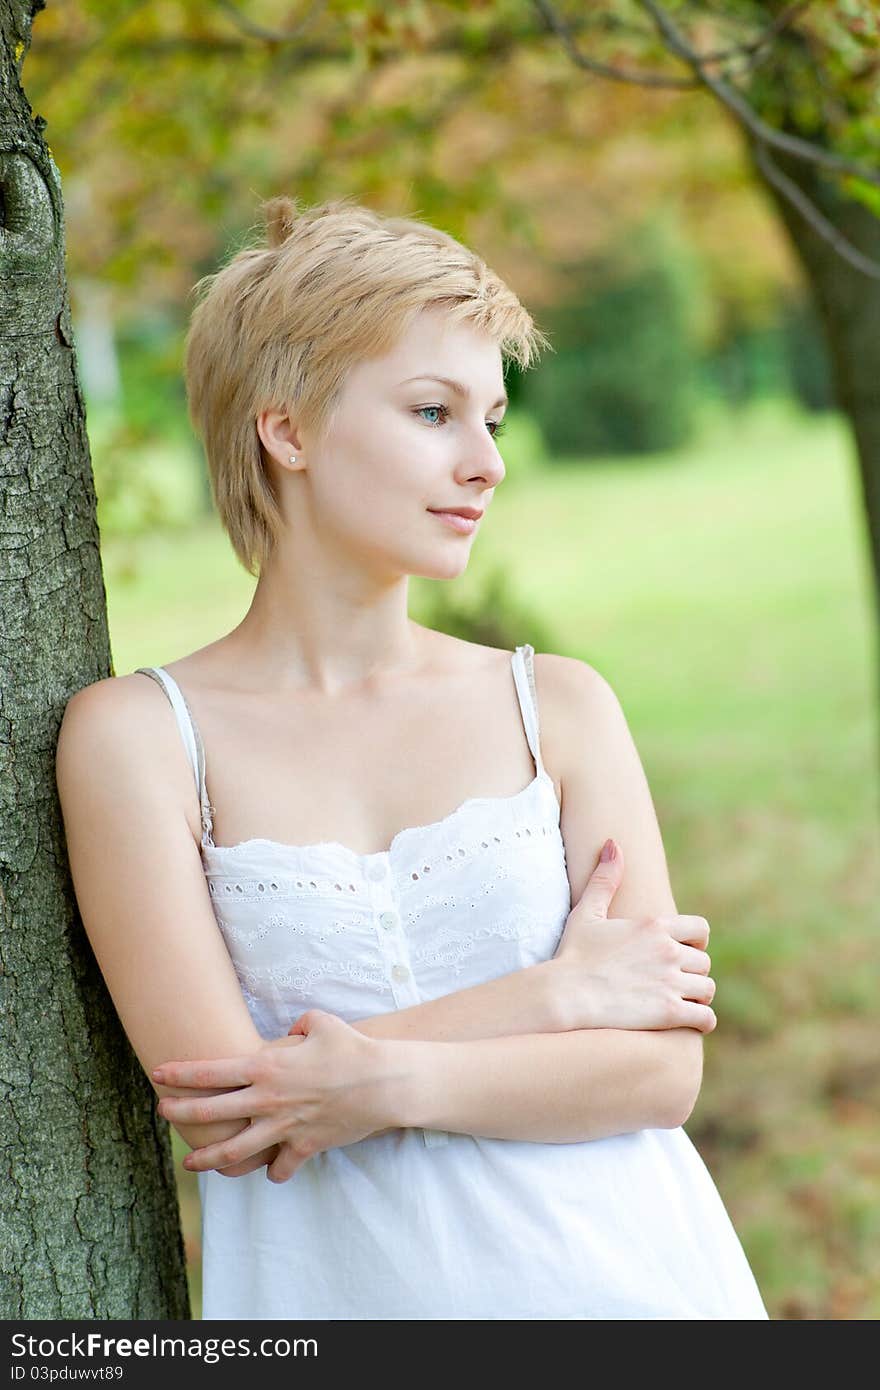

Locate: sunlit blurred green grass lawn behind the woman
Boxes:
[103,406,880,1319]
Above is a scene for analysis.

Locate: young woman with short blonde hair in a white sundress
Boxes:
[57,197,767,1319]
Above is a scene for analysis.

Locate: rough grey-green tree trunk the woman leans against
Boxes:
[0,0,190,1319]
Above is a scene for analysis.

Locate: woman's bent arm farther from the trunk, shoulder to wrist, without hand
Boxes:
[159,656,702,1180]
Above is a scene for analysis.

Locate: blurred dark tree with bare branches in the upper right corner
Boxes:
[534,0,880,642]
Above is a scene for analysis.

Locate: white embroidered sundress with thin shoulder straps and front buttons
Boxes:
[139,645,767,1321]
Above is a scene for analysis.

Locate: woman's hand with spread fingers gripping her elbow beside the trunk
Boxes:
[153,1009,389,1183]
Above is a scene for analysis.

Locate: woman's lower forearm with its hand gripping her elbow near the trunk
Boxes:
[161,1009,685,1183]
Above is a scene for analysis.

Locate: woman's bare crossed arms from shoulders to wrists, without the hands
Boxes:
[57,656,702,1176]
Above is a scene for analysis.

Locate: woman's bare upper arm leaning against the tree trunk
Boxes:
[56,676,269,1148]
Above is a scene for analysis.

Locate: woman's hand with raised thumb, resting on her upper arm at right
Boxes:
[553,842,717,1033]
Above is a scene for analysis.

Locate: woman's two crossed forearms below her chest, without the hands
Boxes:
[346,960,702,1144]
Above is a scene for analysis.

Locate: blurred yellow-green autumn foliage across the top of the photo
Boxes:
[20,0,880,636]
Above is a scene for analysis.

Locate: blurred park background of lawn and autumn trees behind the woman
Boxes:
[24,0,880,1319]
